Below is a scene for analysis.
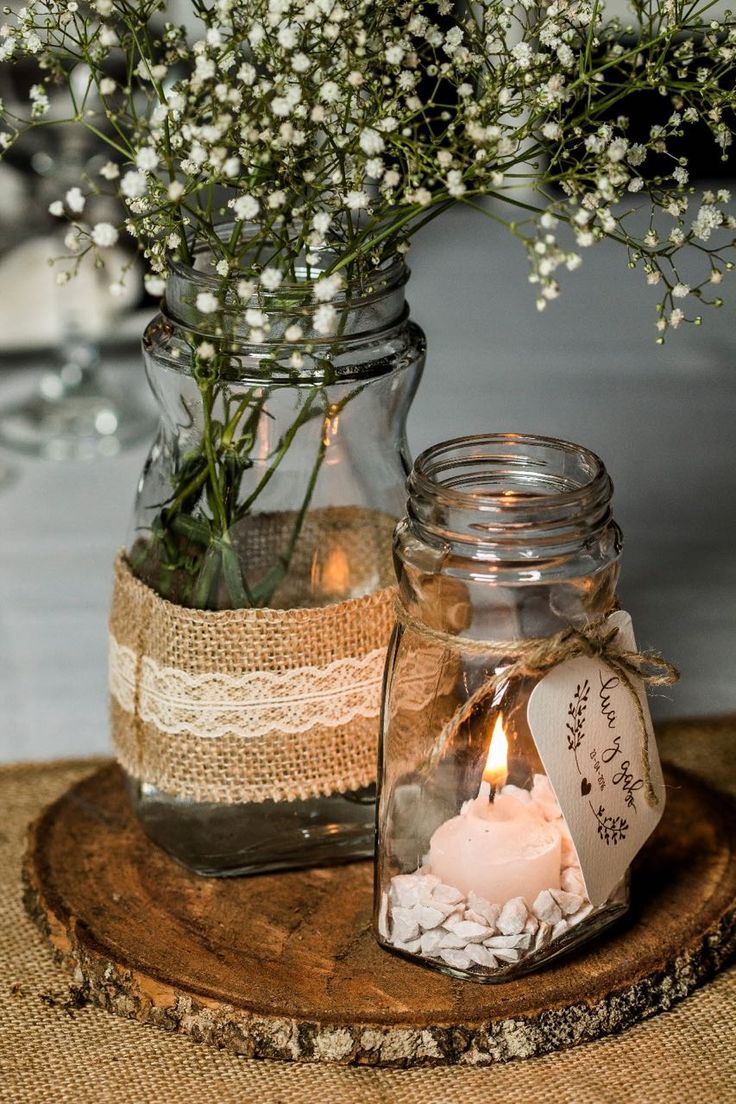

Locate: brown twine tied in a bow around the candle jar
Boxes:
[396,599,680,806]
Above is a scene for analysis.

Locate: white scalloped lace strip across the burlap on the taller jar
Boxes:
[109,635,386,740]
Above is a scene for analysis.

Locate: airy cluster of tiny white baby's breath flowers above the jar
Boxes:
[0,0,736,340]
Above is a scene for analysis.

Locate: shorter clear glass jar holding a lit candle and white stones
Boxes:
[375,434,628,981]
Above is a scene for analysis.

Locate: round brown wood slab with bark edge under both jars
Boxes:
[25,765,736,1065]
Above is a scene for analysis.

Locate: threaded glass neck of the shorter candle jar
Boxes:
[407,434,614,565]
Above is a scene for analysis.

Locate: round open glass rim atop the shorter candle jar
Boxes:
[409,433,612,516]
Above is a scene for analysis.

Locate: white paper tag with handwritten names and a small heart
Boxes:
[527,611,664,904]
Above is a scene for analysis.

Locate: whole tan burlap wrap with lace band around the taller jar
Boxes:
[109,555,395,803]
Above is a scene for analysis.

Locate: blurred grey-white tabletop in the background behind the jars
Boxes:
[0,212,736,761]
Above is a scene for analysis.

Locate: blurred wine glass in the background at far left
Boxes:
[0,66,154,459]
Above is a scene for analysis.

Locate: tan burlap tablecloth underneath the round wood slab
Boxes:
[0,716,736,1104]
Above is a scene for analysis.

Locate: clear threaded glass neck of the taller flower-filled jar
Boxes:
[163,257,409,342]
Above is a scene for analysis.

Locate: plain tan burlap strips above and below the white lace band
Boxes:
[109,555,394,803]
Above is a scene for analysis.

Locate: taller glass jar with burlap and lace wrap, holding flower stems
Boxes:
[110,252,425,875]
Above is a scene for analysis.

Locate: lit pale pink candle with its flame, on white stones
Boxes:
[429,714,561,907]
